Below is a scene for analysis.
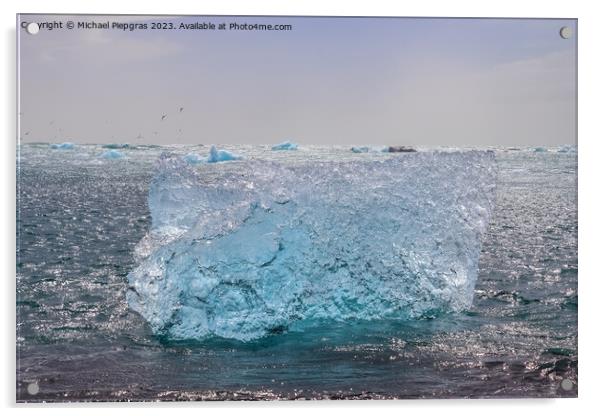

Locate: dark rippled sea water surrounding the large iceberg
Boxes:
[16,144,578,401]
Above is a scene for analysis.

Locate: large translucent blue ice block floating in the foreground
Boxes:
[127,151,496,341]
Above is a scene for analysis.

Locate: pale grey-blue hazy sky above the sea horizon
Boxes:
[18,15,577,146]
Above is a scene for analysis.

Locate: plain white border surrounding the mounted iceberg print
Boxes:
[0,0,602,416]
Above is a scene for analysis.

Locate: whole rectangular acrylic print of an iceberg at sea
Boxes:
[16,15,578,401]
